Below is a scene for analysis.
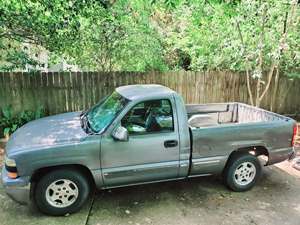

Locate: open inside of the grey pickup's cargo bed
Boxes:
[186,102,288,128]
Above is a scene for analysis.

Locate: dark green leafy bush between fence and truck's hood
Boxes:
[0,105,44,136]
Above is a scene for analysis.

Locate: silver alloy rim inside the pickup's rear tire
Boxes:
[234,162,256,186]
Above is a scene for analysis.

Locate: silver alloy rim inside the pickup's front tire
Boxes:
[46,179,79,208]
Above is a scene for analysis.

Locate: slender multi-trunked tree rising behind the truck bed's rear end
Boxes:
[236,0,297,107]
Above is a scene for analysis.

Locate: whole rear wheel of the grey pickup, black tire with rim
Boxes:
[224,154,261,192]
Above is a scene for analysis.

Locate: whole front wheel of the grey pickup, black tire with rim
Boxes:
[33,169,90,216]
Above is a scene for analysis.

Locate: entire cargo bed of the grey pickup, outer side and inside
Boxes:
[186,103,295,176]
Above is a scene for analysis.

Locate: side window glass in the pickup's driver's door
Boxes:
[121,99,174,134]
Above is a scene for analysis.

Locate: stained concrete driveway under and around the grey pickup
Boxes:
[0,140,300,225]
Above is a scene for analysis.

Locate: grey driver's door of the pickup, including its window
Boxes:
[101,98,179,187]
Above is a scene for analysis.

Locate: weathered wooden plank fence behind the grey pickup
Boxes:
[0,72,300,114]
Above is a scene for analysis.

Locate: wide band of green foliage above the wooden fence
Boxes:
[0,0,300,76]
